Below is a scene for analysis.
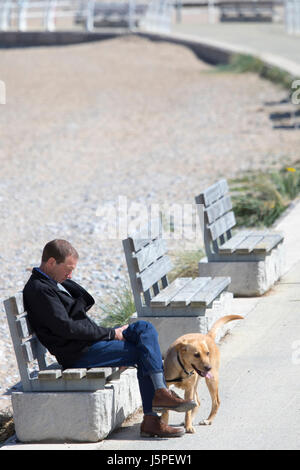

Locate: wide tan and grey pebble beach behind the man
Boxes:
[0,36,299,409]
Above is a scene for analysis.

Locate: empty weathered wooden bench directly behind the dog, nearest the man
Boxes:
[123,221,233,357]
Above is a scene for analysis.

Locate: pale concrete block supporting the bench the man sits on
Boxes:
[12,369,141,442]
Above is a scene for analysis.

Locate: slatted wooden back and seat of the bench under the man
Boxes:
[4,292,120,392]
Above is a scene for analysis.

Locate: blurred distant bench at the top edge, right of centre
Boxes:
[218,0,274,22]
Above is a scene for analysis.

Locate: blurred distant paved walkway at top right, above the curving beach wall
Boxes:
[171,9,300,76]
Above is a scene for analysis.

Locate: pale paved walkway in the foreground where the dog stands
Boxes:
[2,202,300,451]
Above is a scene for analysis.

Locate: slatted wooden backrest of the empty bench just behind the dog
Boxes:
[123,219,173,314]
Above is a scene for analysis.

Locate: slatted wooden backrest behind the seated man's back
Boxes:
[4,292,48,392]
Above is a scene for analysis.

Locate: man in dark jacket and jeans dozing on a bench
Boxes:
[23,239,196,437]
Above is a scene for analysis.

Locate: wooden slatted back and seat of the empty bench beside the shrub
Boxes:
[195,179,283,293]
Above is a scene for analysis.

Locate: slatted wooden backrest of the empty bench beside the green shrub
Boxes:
[195,179,236,260]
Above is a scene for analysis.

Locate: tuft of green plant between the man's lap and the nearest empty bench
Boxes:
[100,285,135,328]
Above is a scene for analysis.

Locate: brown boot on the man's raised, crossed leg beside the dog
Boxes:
[152,388,197,412]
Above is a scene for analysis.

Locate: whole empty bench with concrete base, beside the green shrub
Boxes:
[195,179,284,296]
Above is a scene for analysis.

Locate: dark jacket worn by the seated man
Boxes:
[23,269,115,368]
